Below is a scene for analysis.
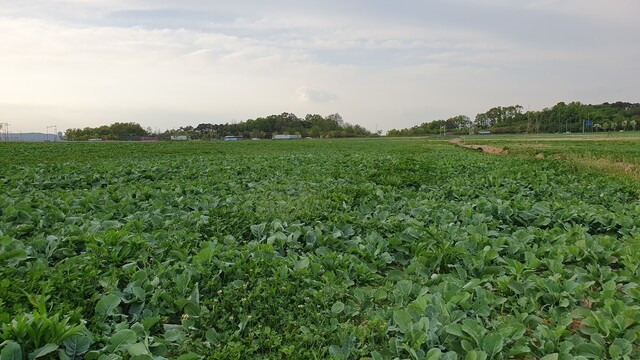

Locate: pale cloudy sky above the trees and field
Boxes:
[0,0,640,132]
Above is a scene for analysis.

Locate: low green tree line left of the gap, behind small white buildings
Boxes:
[65,112,374,141]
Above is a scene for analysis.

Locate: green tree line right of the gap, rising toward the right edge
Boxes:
[388,101,640,136]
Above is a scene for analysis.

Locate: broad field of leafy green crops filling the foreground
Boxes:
[0,139,640,360]
